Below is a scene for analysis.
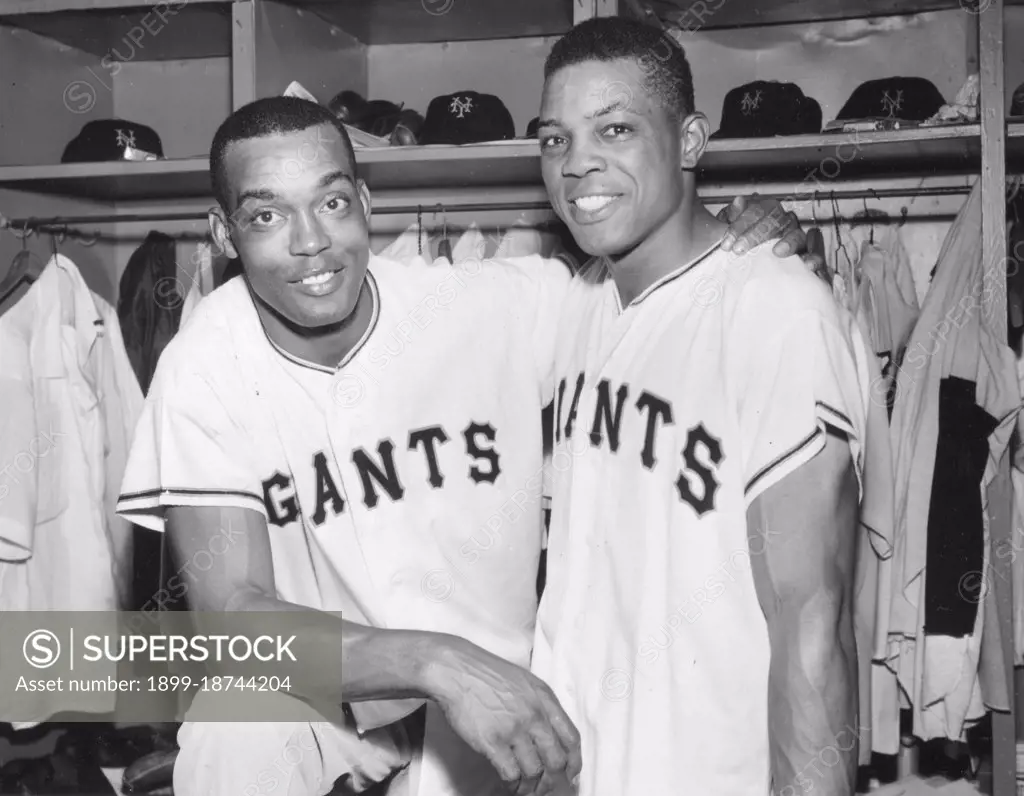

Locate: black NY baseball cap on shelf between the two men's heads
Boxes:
[418,91,515,144]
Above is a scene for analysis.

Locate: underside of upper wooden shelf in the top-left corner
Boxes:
[0,0,231,62]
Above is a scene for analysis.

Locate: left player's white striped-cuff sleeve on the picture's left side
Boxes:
[117,358,266,531]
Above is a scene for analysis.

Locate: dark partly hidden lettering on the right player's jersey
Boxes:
[555,373,725,516]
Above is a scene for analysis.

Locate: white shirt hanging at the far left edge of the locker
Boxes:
[0,255,142,726]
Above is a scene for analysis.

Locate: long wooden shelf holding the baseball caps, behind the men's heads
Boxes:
[0,124,991,202]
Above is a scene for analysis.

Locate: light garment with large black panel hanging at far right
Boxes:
[889,184,1020,740]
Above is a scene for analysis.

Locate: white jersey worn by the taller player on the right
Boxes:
[534,243,868,796]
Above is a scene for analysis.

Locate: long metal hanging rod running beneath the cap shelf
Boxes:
[0,178,991,234]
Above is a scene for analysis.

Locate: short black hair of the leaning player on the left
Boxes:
[210,96,355,212]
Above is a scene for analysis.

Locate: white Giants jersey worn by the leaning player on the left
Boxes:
[119,257,570,796]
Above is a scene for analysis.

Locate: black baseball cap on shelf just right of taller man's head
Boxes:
[711,80,821,138]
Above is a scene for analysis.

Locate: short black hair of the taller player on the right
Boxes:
[544,16,694,121]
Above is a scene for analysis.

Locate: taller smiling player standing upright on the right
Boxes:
[532,18,868,796]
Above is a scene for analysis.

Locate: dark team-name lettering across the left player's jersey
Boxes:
[263,422,502,526]
